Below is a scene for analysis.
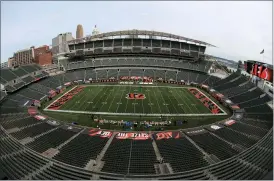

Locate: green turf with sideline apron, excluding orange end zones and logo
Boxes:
[40,84,231,131]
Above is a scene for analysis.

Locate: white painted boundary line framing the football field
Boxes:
[44,84,227,117]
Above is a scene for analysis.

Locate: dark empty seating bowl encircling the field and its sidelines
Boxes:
[0,66,273,180]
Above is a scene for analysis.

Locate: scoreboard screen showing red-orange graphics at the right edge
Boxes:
[244,60,273,82]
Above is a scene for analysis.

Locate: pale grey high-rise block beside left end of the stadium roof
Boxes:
[52,32,73,55]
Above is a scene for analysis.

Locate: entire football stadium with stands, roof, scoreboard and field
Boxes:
[0,30,273,180]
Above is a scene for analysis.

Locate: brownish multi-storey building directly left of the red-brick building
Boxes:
[11,46,34,67]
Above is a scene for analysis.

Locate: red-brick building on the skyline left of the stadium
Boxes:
[34,45,52,65]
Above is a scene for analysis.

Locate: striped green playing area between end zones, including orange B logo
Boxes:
[46,85,226,116]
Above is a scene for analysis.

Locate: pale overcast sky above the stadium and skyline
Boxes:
[1,1,272,64]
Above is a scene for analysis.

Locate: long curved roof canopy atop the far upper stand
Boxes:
[68,29,216,47]
